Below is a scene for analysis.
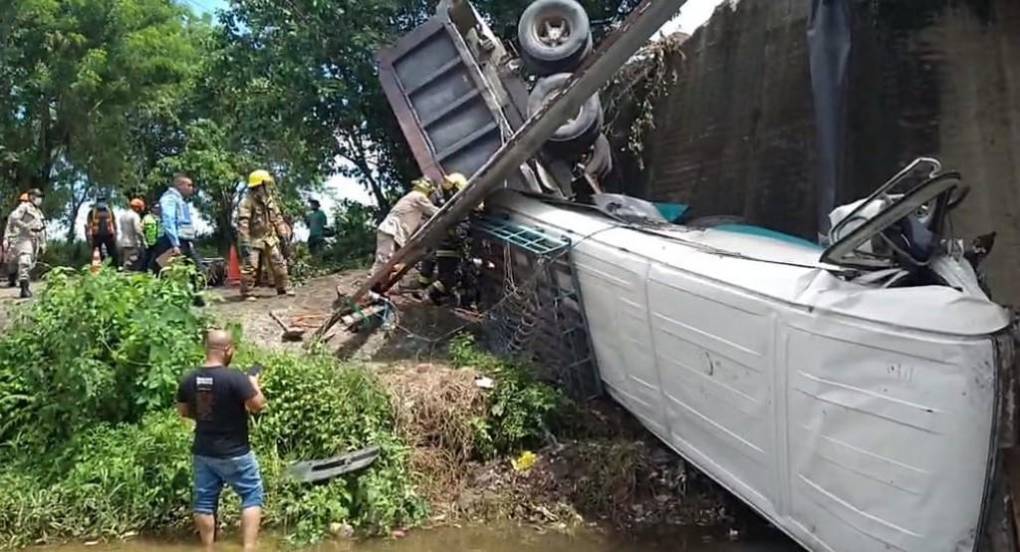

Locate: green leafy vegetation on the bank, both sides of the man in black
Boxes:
[0,270,562,548]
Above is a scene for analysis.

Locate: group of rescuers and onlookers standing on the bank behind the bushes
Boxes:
[3,169,473,305]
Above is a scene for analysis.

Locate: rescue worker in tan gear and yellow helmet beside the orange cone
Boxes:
[238,170,294,301]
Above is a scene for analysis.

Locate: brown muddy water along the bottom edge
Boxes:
[39,525,801,552]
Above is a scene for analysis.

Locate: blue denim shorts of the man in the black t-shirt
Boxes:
[194,452,263,514]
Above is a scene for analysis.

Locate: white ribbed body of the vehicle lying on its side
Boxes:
[488,192,1010,552]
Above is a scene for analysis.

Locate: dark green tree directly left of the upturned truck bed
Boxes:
[215,0,428,211]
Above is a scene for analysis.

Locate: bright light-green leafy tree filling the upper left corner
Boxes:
[0,0,208,228]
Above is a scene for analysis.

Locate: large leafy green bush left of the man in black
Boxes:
[0,267,205,448]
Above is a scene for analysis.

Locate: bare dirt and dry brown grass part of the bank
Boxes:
[212,270,779,539]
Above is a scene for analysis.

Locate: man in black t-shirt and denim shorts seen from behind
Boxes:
[177,330,266,552]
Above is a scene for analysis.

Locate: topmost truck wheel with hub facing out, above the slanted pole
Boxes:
[517,0,592,77]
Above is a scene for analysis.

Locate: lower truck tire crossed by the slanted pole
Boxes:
[527,72,602,158]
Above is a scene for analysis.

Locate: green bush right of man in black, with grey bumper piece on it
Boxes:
[239,351,425,543]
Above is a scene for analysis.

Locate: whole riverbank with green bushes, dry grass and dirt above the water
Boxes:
[0,272,787,547]
